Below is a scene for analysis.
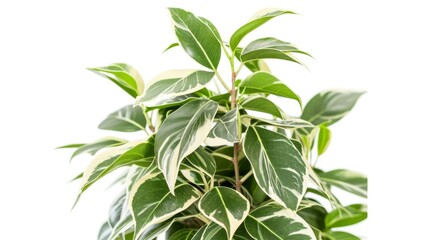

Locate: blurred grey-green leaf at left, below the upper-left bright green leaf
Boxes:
[98,105,146,132]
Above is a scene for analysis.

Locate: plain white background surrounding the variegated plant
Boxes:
[0,0,429,240]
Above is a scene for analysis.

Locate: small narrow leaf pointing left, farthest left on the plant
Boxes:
[67,137,127,161]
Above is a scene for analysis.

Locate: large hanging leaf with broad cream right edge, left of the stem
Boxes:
[155,99,218,192]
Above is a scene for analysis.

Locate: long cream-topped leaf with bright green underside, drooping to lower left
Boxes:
[81,136,155,192]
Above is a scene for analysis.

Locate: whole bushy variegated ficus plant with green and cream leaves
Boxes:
[64,8,367,240]
